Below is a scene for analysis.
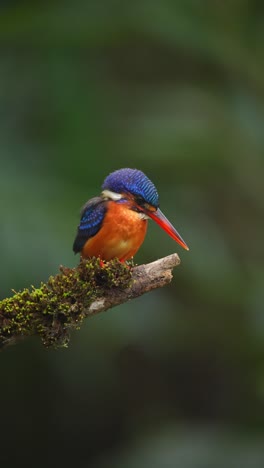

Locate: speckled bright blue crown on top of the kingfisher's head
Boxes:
[102,168,159,208]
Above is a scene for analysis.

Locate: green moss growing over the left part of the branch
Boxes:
[0,258,131,347]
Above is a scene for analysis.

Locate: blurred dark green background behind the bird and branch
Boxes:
[0,0,264,468]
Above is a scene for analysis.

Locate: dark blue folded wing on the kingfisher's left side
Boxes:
[73,197,107,253]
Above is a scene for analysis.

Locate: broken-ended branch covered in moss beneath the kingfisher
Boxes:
[0,254,180,348]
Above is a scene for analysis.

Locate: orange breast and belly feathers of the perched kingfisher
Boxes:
[82,201,148,261]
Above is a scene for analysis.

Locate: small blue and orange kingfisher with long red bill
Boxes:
[73,168,189,262]
